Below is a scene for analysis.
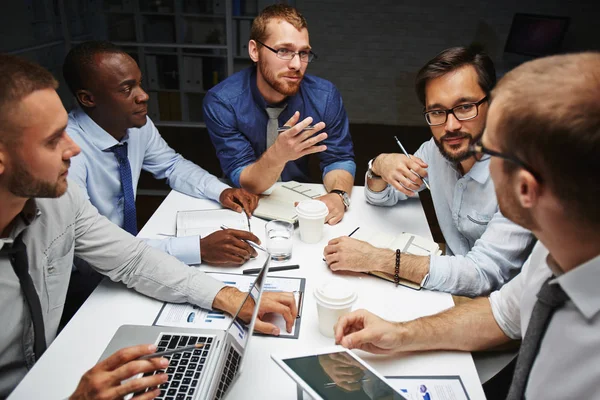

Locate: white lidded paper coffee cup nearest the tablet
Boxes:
[315,279,358,338]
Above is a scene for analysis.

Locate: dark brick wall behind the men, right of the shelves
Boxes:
[296,0,600,125]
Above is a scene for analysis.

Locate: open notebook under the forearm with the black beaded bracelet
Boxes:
[352,227,442,290]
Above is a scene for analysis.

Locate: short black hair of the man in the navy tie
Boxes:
[63,40,127,96]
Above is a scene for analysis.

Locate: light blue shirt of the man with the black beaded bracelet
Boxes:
[365,138,535,297]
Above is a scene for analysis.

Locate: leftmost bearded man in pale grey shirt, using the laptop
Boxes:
[0,54,297,399]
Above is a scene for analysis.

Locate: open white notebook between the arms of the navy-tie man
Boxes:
[176,209,250,237]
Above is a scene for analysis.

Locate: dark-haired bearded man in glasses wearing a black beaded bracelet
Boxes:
[324,47,534,297]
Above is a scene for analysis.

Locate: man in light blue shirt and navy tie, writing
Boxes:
[63,41,258,265]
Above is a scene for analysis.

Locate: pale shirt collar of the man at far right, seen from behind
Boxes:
[548,255,600,319]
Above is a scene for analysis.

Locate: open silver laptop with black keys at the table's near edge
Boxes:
[100,256,271,400]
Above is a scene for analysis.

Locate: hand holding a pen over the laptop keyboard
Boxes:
[70,344,169,400]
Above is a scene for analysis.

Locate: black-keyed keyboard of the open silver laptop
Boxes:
[136,333,214,400]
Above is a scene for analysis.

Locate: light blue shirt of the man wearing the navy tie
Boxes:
[67,107,229,264]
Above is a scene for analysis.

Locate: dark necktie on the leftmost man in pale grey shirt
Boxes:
[0,233,46,360]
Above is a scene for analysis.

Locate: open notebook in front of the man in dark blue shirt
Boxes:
[254,181,326,224]
